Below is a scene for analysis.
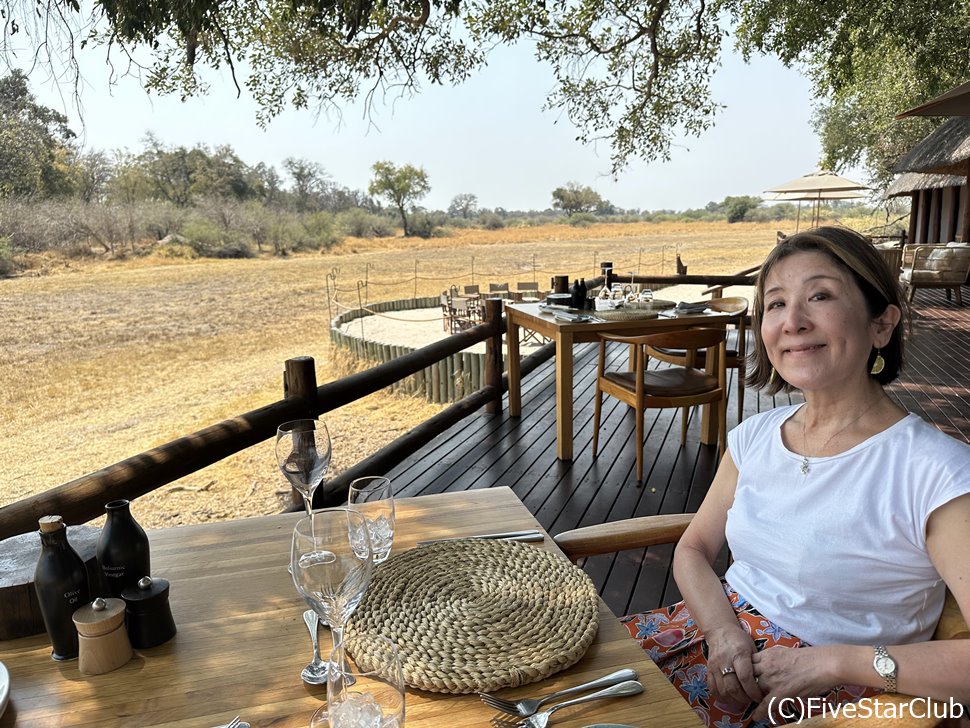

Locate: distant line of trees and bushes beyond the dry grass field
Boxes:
[0,70,876,275]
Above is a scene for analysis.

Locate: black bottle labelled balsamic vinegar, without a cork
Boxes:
[97,500,152,597]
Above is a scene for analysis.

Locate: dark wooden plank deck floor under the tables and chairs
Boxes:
[389,288,970,614]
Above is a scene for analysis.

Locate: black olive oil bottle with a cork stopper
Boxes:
[34,516,91,660]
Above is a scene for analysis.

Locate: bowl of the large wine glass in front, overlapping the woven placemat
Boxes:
[290,508,374,720]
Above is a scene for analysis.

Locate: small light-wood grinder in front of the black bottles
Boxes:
[74,597,132,675]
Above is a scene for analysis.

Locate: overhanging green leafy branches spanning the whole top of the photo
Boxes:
[7,0,970,177]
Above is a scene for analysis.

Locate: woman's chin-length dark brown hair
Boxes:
[746,227,906,394]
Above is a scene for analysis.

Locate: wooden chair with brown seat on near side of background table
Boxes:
[593,328,727,485]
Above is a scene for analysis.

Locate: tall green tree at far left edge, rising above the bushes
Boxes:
[0,70,75,197]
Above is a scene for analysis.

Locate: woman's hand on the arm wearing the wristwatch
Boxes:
[751,647,834,720]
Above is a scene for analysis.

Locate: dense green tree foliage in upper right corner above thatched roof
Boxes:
[726,0,970,187]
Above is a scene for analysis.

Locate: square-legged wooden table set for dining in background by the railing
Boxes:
[505,303,733,460]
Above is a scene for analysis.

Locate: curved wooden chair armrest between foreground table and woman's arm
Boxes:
[553,513,694,562]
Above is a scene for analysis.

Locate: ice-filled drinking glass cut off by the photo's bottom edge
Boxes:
[327,634,404,728]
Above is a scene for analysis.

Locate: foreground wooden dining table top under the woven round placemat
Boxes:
[0,487,700,728]
